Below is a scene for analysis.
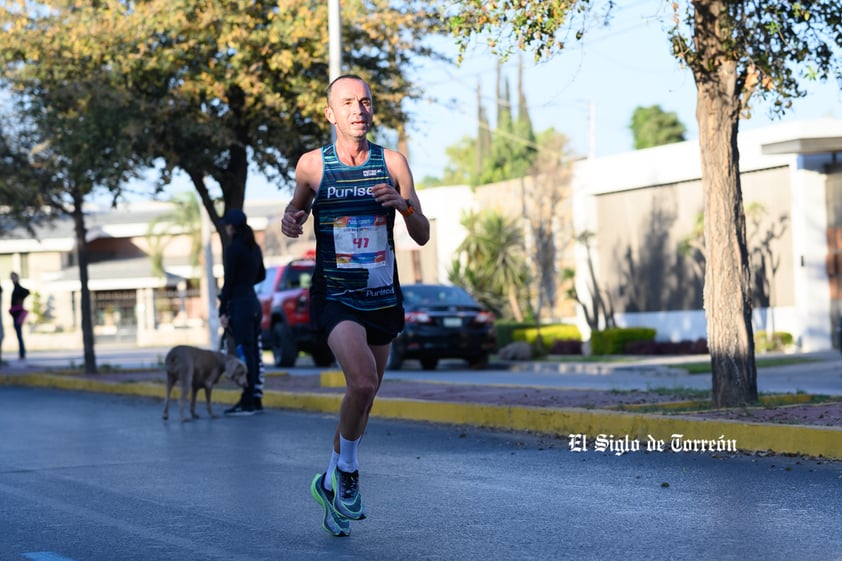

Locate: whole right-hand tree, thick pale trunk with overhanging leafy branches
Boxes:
[445,0,842,407]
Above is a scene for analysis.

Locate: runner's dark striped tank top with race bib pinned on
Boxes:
[310,143,402,310]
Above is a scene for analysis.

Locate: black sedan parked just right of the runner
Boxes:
[388,284,497,370]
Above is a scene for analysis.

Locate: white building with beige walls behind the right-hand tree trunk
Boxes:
[573,119,842,351]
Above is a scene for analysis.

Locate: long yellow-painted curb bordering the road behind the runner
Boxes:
[0,374,842,459]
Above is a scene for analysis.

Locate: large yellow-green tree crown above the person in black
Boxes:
[0,0,440,240]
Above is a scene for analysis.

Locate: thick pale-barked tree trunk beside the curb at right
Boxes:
[694,0,757,407]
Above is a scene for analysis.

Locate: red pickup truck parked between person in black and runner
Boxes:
[255,259,334,367]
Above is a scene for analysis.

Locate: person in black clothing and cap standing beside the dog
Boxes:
[219,209,266,415]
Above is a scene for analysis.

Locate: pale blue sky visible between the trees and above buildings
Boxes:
[121,0,842,200]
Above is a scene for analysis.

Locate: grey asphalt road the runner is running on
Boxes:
[0,387,842,561]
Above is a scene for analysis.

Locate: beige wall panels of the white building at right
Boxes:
[595,167,794,313]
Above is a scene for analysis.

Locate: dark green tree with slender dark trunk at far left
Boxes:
[0,79,149,374]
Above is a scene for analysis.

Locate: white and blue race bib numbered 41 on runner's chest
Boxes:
[333,216,389,269]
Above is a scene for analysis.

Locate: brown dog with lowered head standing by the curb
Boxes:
[163,345,247,421]
